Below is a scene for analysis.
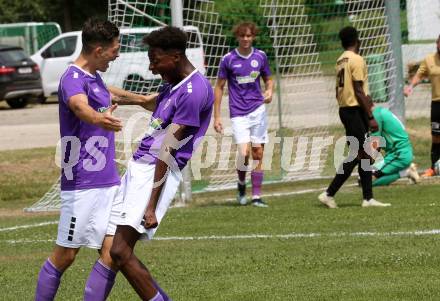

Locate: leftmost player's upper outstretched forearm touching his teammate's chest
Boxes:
[108,86,159,111]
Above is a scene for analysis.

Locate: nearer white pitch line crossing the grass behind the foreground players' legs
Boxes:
[4,229,440,244]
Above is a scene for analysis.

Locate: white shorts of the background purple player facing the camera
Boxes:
[231,104,269,144]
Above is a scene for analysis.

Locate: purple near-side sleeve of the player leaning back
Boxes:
[172,91,206,127]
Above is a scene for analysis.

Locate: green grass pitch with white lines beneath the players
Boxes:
[0,116,440,301]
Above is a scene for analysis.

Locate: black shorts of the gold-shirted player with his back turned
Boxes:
[339,107,368,149]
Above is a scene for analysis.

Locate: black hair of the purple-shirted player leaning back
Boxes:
[143,26,188,53]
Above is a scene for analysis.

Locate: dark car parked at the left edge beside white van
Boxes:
[0,45,43,108]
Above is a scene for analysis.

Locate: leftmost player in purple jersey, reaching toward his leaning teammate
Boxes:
[35,20,155,301]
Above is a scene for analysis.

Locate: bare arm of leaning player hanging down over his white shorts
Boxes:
[144,123,188,229]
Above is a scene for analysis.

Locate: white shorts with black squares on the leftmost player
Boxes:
[56,186,119,249]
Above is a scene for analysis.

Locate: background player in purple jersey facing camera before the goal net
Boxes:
[214,22,273,207]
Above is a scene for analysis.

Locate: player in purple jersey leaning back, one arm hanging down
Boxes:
[110,27,214,301]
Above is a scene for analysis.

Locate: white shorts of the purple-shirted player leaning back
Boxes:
[108,160,182,239]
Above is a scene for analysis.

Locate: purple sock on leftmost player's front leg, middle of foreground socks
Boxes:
[84,260,116,301]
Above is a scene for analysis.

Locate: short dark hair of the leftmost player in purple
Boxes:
[81,18,119,53]
